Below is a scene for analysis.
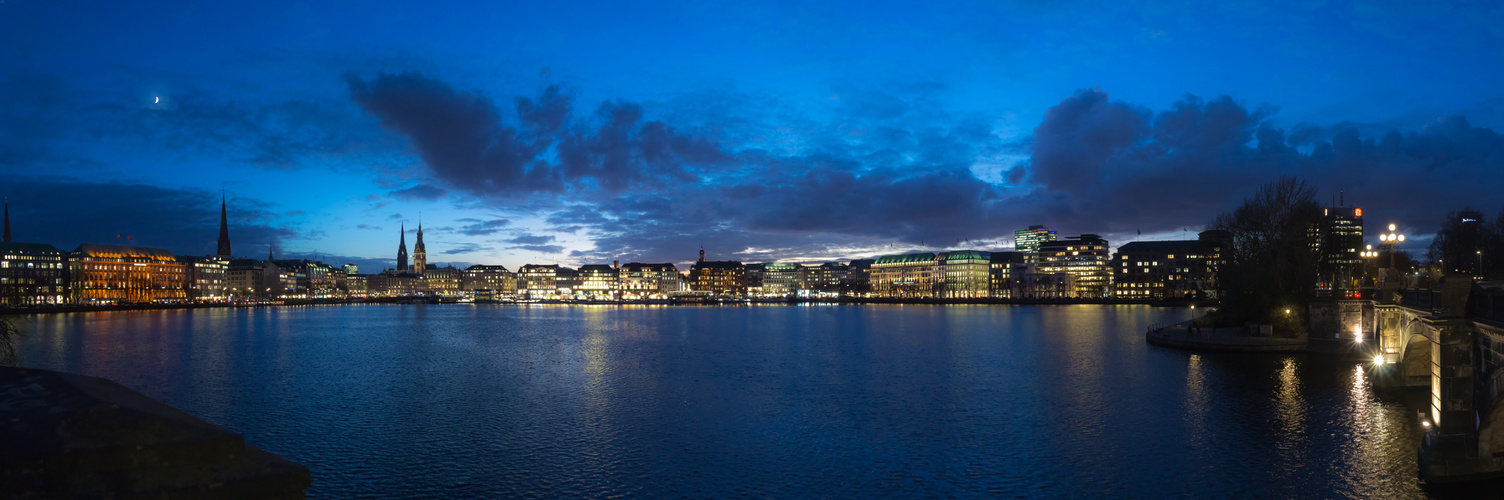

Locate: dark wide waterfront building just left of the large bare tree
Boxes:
[1113,230,1226,300]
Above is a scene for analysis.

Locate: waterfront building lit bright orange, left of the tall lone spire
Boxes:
[68,242,188,304]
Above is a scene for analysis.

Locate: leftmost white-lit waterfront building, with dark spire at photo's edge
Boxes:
[0,240,68,306]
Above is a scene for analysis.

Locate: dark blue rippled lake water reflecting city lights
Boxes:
[5,304,1449,498]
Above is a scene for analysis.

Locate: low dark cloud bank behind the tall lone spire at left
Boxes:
[3,176,299,256]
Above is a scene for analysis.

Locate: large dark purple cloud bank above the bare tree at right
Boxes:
[1017,90,1504,237]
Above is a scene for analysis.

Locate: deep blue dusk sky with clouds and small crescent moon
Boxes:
[0,0,1504,273]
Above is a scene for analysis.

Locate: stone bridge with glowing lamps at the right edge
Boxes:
[1310,277,1504,483]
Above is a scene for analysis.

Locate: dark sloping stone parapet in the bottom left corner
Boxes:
[0,367,310,498]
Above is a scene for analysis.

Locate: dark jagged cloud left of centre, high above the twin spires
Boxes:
[346,72,729,196]
